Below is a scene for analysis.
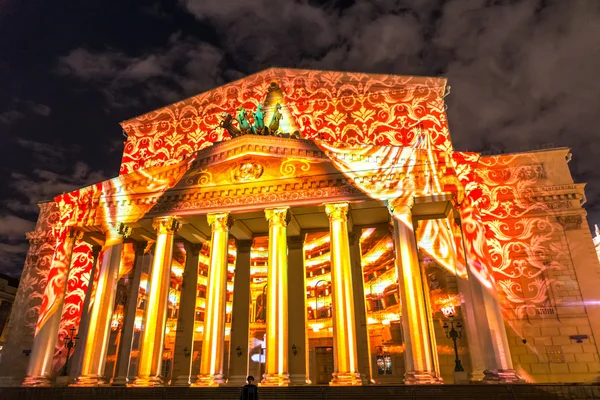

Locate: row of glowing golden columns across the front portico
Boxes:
[24,203,512,386]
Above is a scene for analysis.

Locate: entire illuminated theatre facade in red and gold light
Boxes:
[0,69,600,387]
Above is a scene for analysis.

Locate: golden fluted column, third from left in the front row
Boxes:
[133,217,180,386]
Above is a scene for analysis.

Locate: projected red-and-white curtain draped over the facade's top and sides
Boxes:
[27,69,562,372]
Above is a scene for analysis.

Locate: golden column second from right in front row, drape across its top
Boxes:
[390,206,441,384]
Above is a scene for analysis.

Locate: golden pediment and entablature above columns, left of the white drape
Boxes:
[87,135,367,226]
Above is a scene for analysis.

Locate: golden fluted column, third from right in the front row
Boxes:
[325,203,362,386]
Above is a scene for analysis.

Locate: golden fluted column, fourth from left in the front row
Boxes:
[194,213,232,386]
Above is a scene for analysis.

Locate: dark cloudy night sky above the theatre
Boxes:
[0,0,600,276]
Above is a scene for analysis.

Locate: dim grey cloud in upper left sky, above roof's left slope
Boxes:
[58,34,224,108]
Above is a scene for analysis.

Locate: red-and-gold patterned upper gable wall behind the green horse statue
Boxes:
[121,69,452,174]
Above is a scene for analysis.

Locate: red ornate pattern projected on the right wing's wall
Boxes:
[477,153,570,318]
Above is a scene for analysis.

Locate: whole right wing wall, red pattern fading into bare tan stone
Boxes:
[480,149,600,382]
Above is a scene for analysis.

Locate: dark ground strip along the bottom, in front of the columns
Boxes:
[0,384,600,400]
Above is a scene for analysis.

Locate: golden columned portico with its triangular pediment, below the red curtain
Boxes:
[12,137,516,388]
